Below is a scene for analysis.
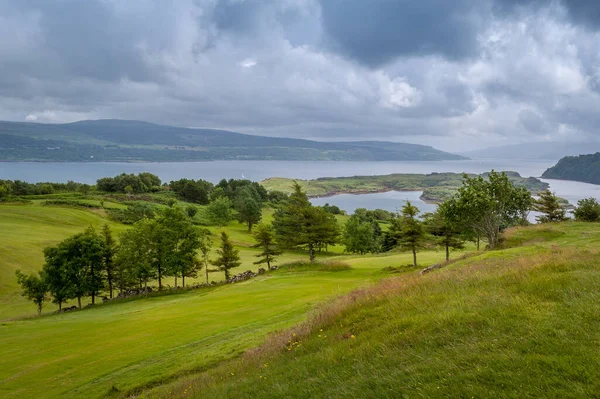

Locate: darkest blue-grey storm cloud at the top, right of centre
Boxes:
[321,0,483,66]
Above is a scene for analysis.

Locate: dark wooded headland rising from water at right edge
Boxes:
[542,152,600,184]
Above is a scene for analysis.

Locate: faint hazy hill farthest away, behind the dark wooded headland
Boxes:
[461,141,600,160]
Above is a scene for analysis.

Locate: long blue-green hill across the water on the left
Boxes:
[0,120,466,162]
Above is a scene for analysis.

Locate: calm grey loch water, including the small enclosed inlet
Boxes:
[0,159,600,216]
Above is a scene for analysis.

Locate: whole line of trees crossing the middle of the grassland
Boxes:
[17,171,600,312]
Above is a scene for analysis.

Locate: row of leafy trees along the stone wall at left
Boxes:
[16,207,281,313]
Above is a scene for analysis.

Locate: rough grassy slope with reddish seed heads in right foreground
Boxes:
[141,223,600,398]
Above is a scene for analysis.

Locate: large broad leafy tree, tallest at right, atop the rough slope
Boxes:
[446,170,533,249]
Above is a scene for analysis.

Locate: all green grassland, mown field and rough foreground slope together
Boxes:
[0,203,600,398]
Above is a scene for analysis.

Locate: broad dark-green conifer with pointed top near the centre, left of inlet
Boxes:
[273,182,340,262]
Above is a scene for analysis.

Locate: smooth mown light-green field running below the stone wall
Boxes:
[0,204,450,397]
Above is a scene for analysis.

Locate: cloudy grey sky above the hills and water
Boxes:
[0,0,600,151]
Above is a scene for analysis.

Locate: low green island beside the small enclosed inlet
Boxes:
[261,171,549,203]
